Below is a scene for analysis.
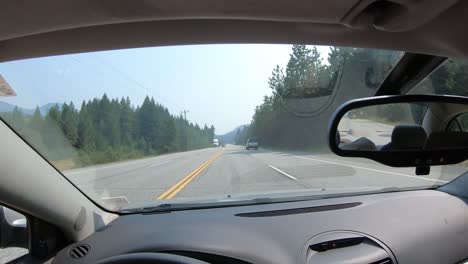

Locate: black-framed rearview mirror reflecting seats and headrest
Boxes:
[329,95,468,168]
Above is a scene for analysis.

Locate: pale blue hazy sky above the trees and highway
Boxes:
[0,44,328,134]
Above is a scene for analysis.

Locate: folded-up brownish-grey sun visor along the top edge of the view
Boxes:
[0,0,359,40]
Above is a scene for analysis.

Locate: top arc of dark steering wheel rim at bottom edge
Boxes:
[96,253,208,264]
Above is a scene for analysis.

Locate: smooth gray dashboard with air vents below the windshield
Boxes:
[54,190,468,264]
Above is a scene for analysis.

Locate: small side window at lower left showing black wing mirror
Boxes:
[0,206,28,263]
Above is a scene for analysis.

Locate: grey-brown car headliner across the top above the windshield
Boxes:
[0,0,468,61]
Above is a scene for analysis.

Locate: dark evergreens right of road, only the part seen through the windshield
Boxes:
[235,45,400,149]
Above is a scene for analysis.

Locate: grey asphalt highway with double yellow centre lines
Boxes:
[64,145,466,209]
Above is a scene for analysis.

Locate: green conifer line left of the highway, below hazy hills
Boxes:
[2,94,215,167]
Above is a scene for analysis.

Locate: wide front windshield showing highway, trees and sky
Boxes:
[0,44,465,210]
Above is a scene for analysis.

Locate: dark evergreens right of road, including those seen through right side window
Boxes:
[235,45,468,149]
